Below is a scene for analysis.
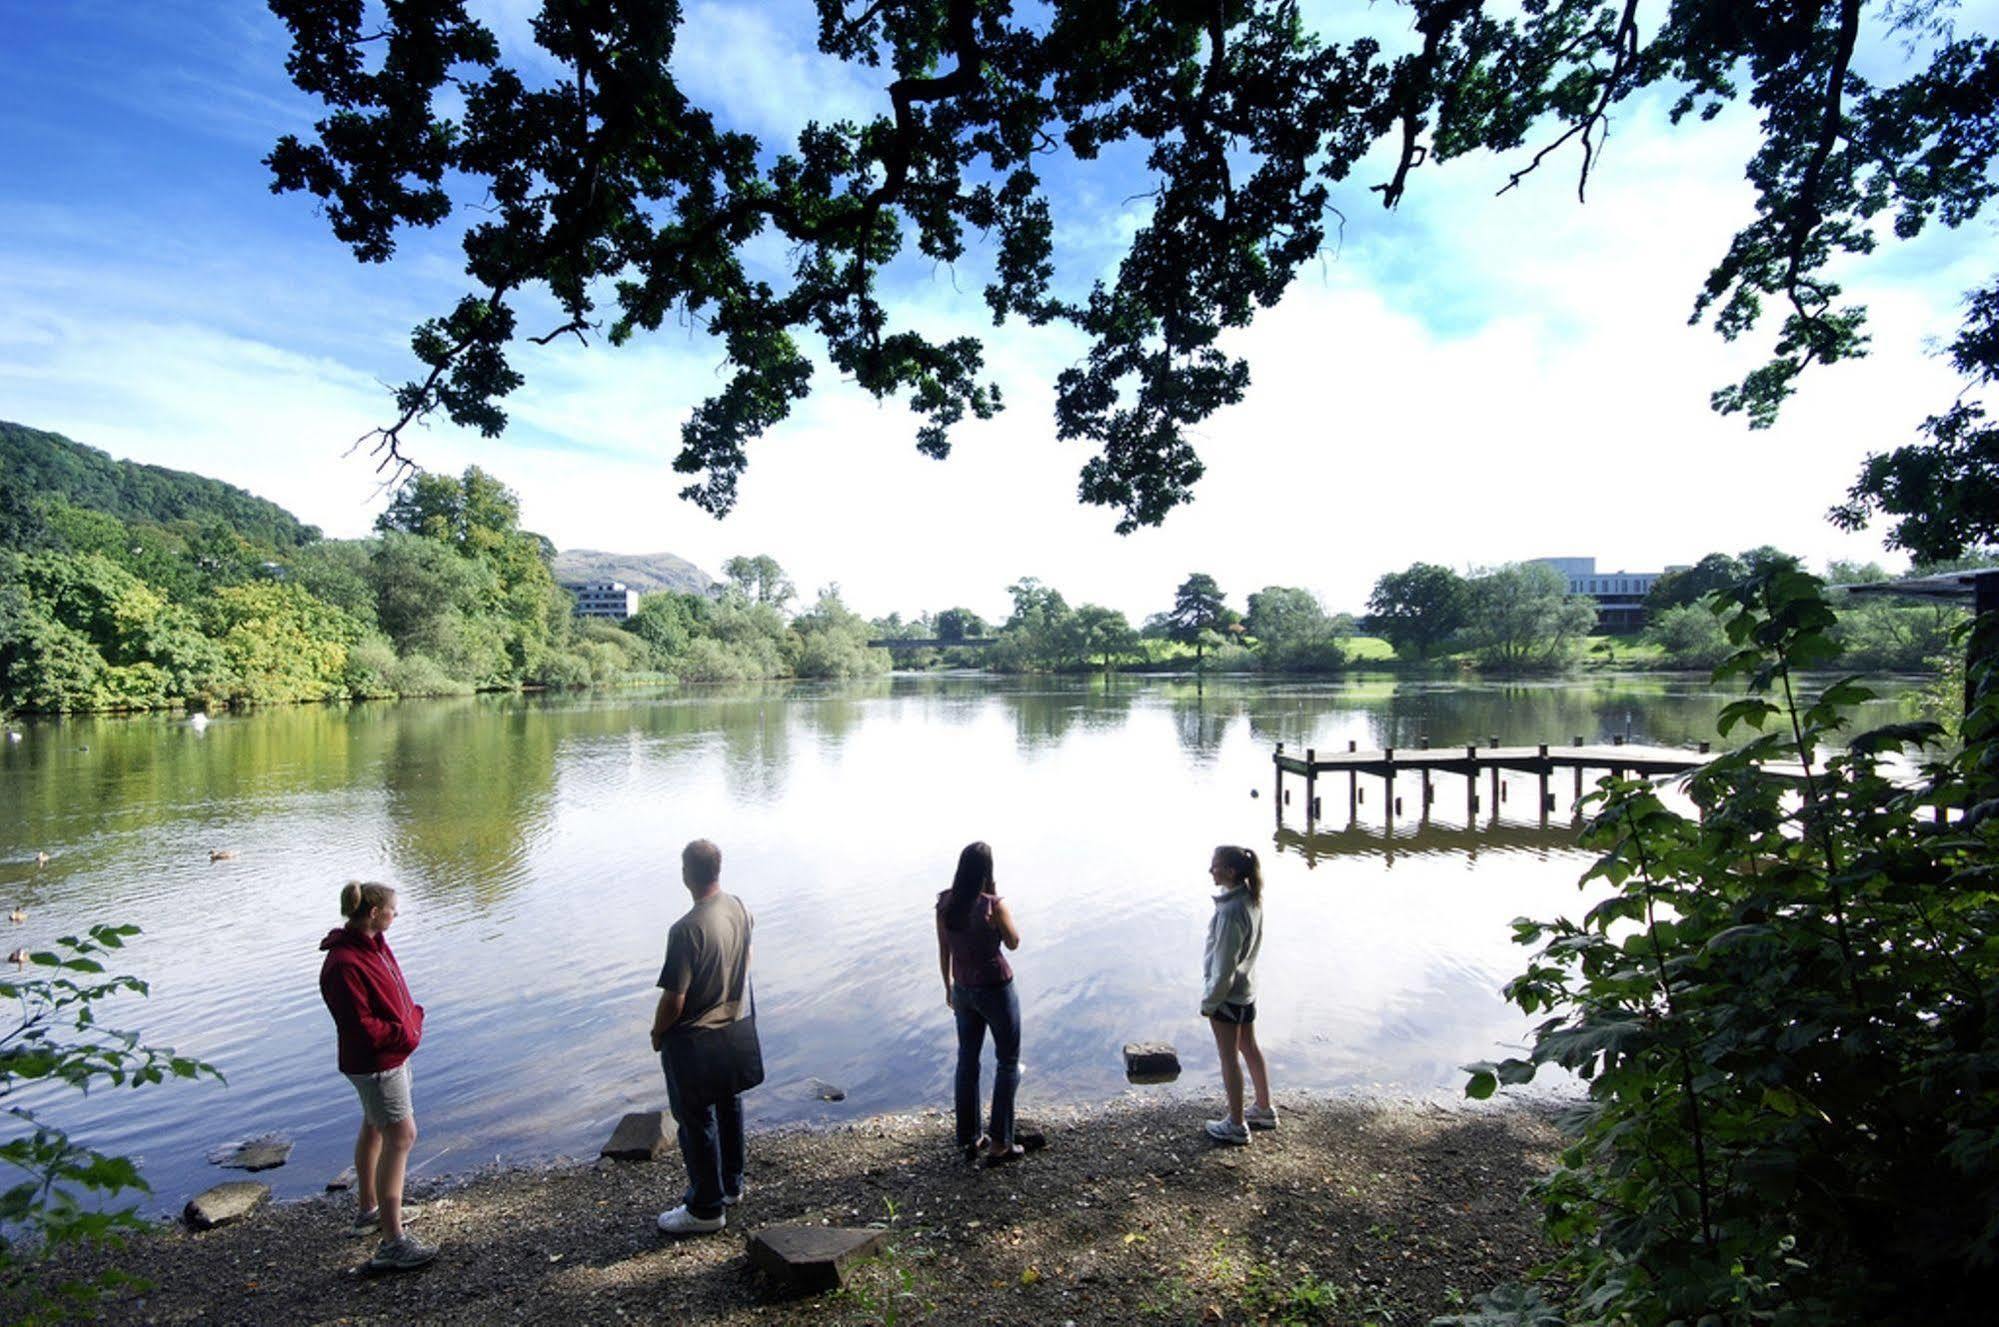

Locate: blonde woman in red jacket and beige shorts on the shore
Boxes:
[320,881,438,1271]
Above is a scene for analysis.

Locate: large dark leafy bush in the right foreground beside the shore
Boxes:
[1467,568,1999,1327]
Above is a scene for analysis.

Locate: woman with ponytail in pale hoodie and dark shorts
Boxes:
[1201,845,1277,1145]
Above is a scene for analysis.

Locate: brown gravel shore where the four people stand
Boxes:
[50,1093,1557,1327]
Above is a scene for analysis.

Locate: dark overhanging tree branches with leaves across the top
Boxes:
[268,0,1999,543]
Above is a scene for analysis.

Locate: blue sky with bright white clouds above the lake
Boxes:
[0,0,1999,616]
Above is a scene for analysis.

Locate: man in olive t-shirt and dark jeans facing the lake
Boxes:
[652,839,754,1235]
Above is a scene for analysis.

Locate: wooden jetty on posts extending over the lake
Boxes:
[1271,737,1709,833]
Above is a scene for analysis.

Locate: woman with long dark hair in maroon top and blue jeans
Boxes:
[938,843,1019,1165]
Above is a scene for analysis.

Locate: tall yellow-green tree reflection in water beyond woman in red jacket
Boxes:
[384,697,562,907]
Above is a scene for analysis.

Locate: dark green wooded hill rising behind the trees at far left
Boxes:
[0,420,320,548]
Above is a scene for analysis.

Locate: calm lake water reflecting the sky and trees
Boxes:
[0,675,1901,1211]
